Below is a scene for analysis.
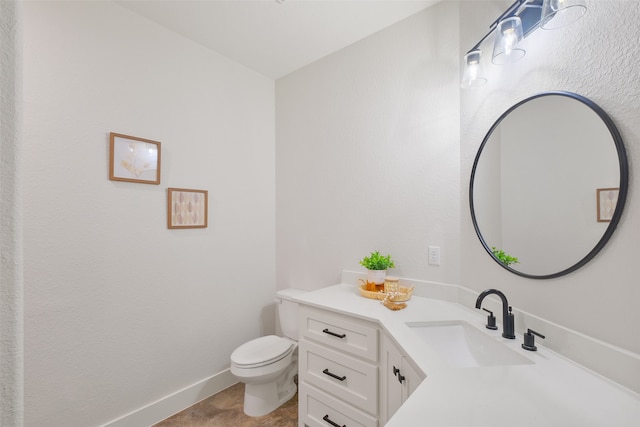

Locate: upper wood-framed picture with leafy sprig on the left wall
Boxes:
[109,132,160,185]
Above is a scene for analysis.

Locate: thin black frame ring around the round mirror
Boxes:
[469,91,629,279]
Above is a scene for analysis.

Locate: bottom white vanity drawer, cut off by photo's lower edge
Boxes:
[298,382,378,427]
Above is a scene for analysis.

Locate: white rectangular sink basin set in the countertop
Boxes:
[407,321,533,368]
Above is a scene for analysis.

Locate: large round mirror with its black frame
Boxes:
[469,92,628,279]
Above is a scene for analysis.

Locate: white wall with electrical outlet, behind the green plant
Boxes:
[276,2,460,289]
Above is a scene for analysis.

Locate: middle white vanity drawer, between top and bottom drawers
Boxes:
[299,339,378,414]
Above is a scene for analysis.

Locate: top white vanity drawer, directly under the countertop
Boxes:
[300,307,378,362]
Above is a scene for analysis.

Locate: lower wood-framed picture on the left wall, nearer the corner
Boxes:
[167,188,209,228]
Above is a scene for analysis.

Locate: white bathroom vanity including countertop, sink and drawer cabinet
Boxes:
[296,284,640,427]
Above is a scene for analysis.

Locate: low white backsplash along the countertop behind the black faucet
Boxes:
[342,270,640,393]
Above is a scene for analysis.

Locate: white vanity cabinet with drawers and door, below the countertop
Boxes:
[298,306,424,427]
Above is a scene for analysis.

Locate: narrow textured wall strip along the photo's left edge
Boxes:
[0,1,24,426]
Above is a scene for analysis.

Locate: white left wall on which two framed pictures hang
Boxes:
[23,1,275,426]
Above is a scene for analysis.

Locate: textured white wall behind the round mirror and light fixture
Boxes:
[460,1,640,353]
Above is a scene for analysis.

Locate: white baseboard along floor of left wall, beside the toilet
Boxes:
[101,369,238,427]
